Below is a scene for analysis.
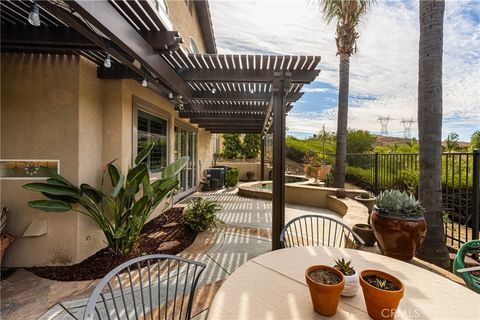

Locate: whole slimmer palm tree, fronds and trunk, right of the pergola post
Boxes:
[320,0,375,188]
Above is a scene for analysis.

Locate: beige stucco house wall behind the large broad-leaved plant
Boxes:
[0,54,212,266]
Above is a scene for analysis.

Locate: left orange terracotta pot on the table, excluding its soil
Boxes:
[305,265,345,317]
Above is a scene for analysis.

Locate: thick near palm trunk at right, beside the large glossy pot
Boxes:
[417,0,450,267]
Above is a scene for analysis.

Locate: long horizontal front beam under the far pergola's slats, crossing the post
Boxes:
[180,69,320,84]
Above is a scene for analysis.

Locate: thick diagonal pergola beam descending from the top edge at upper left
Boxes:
[67,0,192,98]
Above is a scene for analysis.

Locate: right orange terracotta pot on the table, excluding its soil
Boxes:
[360,270,404,320]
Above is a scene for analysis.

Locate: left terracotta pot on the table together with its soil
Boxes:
[305,265,345,317]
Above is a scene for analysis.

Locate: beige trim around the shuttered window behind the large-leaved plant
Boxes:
[132,96,172,180]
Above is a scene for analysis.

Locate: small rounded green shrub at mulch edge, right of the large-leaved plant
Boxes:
[183,198,222,232]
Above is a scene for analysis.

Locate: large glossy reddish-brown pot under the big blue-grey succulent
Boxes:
[371,210,427,261]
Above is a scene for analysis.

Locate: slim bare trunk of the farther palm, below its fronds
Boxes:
[333,54,350,188]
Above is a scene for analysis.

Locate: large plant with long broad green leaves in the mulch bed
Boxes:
[23,143,188,255]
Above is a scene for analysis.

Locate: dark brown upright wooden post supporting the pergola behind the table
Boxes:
[272,72,291,250]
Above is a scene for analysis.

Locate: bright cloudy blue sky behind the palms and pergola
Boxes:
[210,0,480,140]
